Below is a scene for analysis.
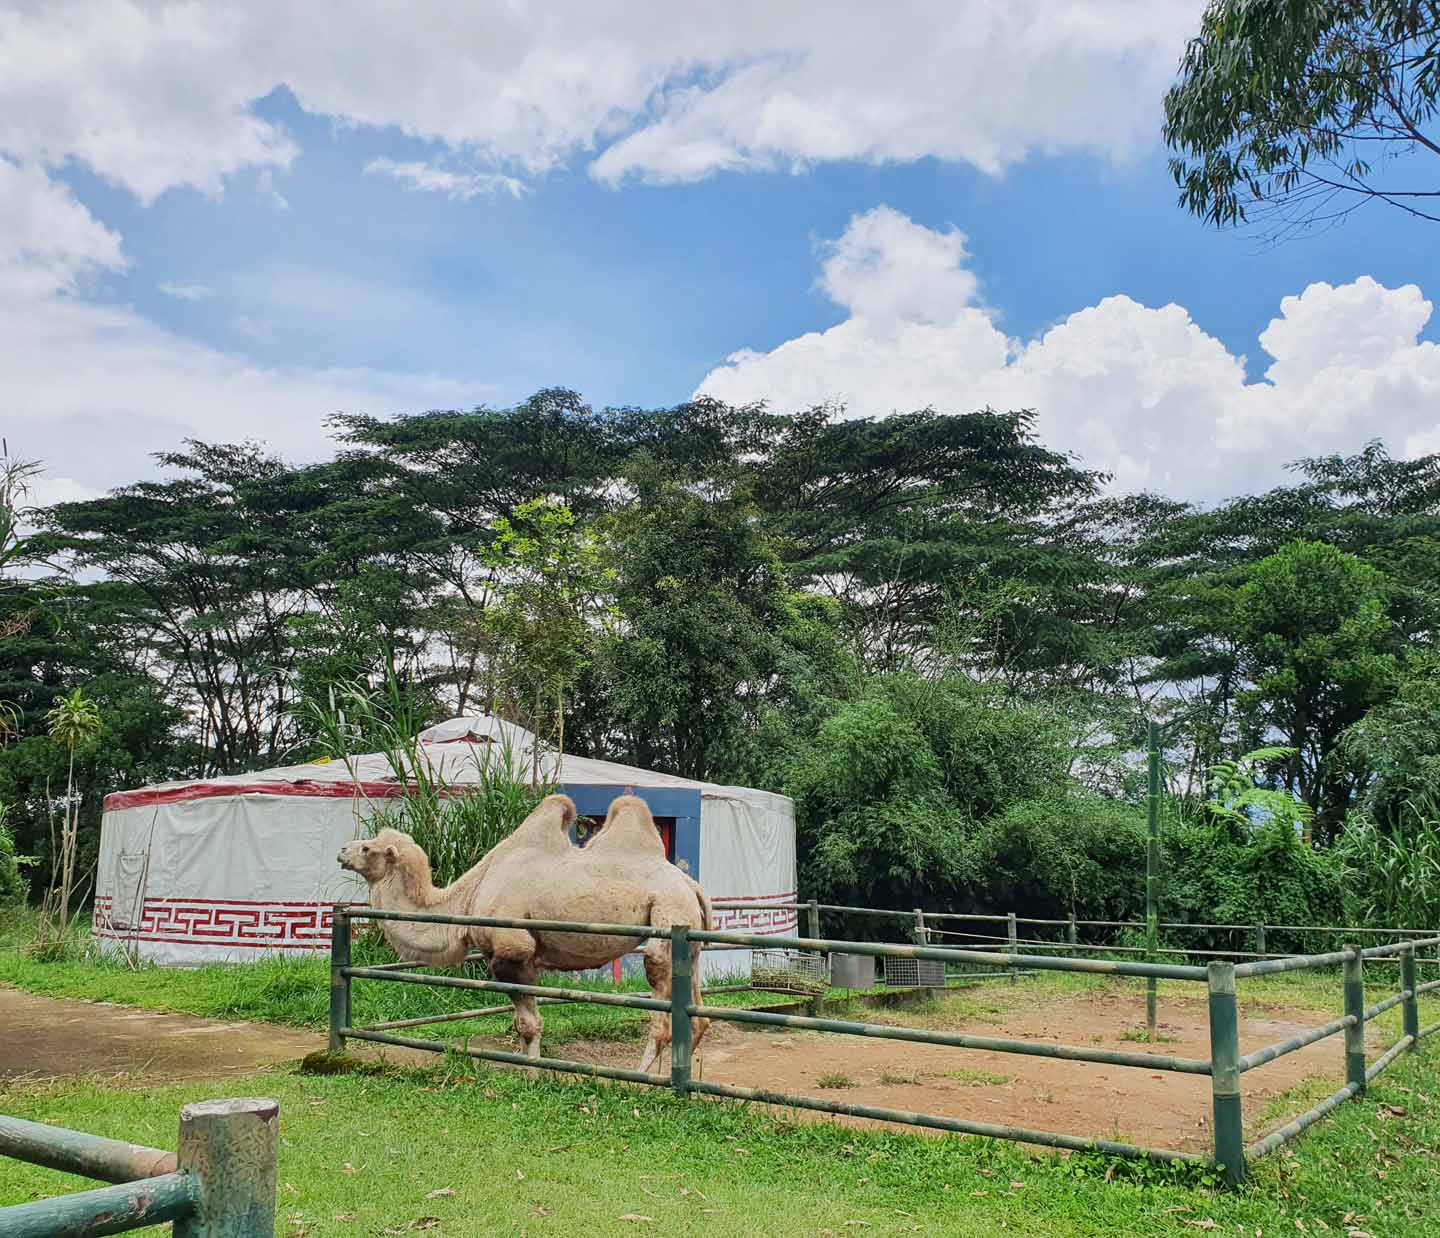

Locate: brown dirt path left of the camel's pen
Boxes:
[0,989,324,1081]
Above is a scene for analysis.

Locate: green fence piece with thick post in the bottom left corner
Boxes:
[0,1100,279,1238]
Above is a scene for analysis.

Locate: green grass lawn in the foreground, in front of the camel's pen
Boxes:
[0,1045,1440,1238]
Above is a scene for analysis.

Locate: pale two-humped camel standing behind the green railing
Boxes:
[338,795,713,1071]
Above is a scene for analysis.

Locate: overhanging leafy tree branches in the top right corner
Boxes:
[1165,0,1440,236]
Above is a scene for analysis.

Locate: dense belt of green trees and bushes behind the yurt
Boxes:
[0,405,1440,967]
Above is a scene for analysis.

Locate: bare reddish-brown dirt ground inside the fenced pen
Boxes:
[549,990,1378,1153]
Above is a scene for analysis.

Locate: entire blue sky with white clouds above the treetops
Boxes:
[8,0,1440,501]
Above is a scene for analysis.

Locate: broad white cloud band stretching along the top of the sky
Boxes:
[0,0,1201,202]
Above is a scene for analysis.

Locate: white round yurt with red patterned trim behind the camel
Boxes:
[94,717,798,976]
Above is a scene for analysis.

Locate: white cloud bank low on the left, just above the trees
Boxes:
[0,158,494,489]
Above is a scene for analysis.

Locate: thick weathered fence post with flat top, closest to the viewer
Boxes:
[174,1098,279,1238]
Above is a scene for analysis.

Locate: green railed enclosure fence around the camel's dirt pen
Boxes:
[330,904,1440,1185]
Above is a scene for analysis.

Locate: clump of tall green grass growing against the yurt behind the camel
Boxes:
[307,677,556,885]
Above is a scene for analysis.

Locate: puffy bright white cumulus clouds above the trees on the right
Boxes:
[700,207,1440,500]
